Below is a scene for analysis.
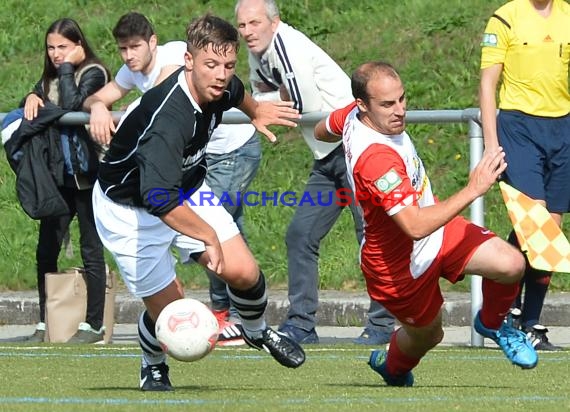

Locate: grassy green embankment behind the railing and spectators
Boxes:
[0,0,570,289]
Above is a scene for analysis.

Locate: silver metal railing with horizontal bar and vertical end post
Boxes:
[0,108,485,347]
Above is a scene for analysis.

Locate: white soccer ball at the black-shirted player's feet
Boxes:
[155,299,218,362]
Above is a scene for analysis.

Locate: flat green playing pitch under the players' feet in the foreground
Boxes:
[0,344,570,412]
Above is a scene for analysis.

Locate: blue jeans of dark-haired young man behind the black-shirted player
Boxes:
[206,133,261,310]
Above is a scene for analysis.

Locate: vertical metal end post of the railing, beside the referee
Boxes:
[469,119,485,347]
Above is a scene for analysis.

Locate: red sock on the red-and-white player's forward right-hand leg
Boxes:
[480,279,520,329]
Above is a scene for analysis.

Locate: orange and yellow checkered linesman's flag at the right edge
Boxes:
[499,182,570,273]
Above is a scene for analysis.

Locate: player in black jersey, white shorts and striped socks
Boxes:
[93,14,305,391]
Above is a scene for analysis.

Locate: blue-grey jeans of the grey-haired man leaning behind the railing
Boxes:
[284,145,395,334]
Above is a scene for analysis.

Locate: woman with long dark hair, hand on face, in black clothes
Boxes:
[24,18,110,343]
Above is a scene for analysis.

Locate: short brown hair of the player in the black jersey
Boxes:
[186,13,239,54]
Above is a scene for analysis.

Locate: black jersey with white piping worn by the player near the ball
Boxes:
[99,68,244,216]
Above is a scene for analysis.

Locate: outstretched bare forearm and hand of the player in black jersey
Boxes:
[239,93,301,143]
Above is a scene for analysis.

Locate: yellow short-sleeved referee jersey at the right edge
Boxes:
[481,0,570,117]
